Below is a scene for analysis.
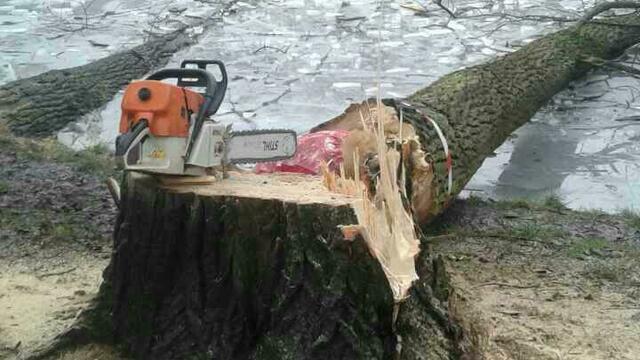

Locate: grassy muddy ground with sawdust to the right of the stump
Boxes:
[430,199,640,359]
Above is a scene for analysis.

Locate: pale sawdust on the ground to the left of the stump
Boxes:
[0,254,107,359]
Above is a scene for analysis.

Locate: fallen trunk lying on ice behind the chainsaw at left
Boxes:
[0,28,194,136]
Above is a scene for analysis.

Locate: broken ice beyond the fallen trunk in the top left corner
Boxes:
[0,0,228,84]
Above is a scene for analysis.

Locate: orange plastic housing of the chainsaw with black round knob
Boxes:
[120,80,204,137]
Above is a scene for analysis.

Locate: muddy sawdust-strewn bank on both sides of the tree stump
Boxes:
[0,133,640,360]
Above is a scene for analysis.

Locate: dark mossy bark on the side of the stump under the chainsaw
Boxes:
[108,174,404,359]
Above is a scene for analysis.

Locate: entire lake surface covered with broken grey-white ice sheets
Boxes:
[0,0,640,211]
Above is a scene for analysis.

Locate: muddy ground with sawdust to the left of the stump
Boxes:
[0,135,115,359]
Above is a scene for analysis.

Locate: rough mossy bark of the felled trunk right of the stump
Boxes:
[391,14,640,221]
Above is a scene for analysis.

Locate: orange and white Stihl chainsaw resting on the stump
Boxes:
[116,60,296,176]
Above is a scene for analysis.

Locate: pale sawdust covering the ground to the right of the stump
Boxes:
[454,267,640,360]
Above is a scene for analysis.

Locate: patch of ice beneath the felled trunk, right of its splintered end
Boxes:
[467,70,640,211]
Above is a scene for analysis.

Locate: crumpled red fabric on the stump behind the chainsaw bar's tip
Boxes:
[255,130,349,175]
